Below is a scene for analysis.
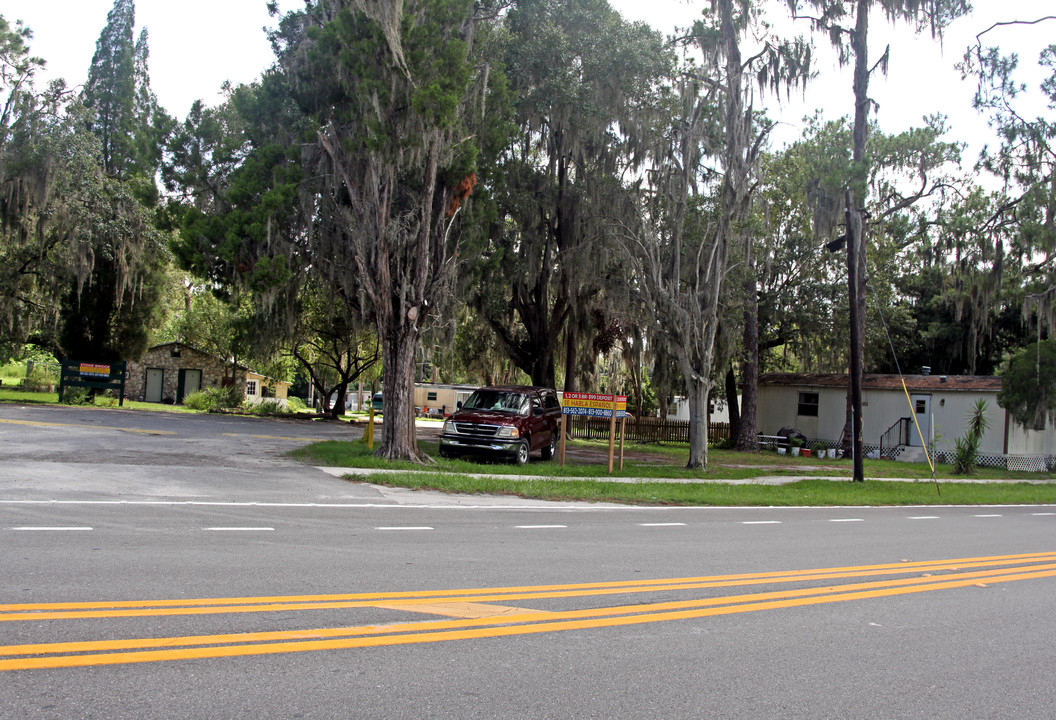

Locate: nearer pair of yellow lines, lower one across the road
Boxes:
[0,565,1056,670]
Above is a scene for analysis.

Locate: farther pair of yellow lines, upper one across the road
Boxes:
[0,553,1056,622]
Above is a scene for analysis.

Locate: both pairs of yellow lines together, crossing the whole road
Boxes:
[0,552,1056,670]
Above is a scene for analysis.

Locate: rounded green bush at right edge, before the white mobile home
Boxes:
[997,338,1056,430]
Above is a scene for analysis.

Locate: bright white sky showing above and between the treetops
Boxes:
[8,0,1056,160]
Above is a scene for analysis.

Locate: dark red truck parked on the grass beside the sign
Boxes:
[440,385,561,465]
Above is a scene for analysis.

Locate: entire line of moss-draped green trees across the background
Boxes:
[0,0,1056,467]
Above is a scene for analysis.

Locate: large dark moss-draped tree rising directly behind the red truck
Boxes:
[463,0,674,386]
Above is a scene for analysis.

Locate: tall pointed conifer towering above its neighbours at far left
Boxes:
[59,0,170,361]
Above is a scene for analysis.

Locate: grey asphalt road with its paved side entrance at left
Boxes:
[0,405,1056,719]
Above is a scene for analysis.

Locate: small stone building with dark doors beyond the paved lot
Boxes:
[125,342,289,403]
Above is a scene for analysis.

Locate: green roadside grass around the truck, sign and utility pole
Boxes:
[290,432,1056,506]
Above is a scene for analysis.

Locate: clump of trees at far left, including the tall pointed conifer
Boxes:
[0,0,167,361]
